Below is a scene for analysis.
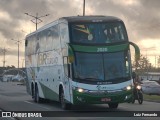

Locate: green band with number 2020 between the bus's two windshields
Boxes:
[70,43,129,52]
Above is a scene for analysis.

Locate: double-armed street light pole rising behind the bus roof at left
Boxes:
[24,13,49,30]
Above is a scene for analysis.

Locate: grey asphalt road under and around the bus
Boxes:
[0,82,160,120]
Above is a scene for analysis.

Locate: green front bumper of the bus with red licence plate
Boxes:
[73,89,133,105]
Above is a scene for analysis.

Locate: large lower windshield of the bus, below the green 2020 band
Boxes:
[73,51,130,81]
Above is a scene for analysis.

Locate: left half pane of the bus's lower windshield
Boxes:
[74,53,104,80]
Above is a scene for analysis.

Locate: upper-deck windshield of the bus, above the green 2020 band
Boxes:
[71,22,128,44]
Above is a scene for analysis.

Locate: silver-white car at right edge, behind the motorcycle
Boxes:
[141,81,160,95]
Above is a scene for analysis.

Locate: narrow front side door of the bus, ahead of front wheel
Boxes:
[63,56,71,101]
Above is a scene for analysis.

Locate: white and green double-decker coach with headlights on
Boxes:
[25,16,140,109]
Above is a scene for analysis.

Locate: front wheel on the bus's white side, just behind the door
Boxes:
[59,89,71,110]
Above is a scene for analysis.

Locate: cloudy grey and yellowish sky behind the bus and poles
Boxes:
[0,0,160,67]
